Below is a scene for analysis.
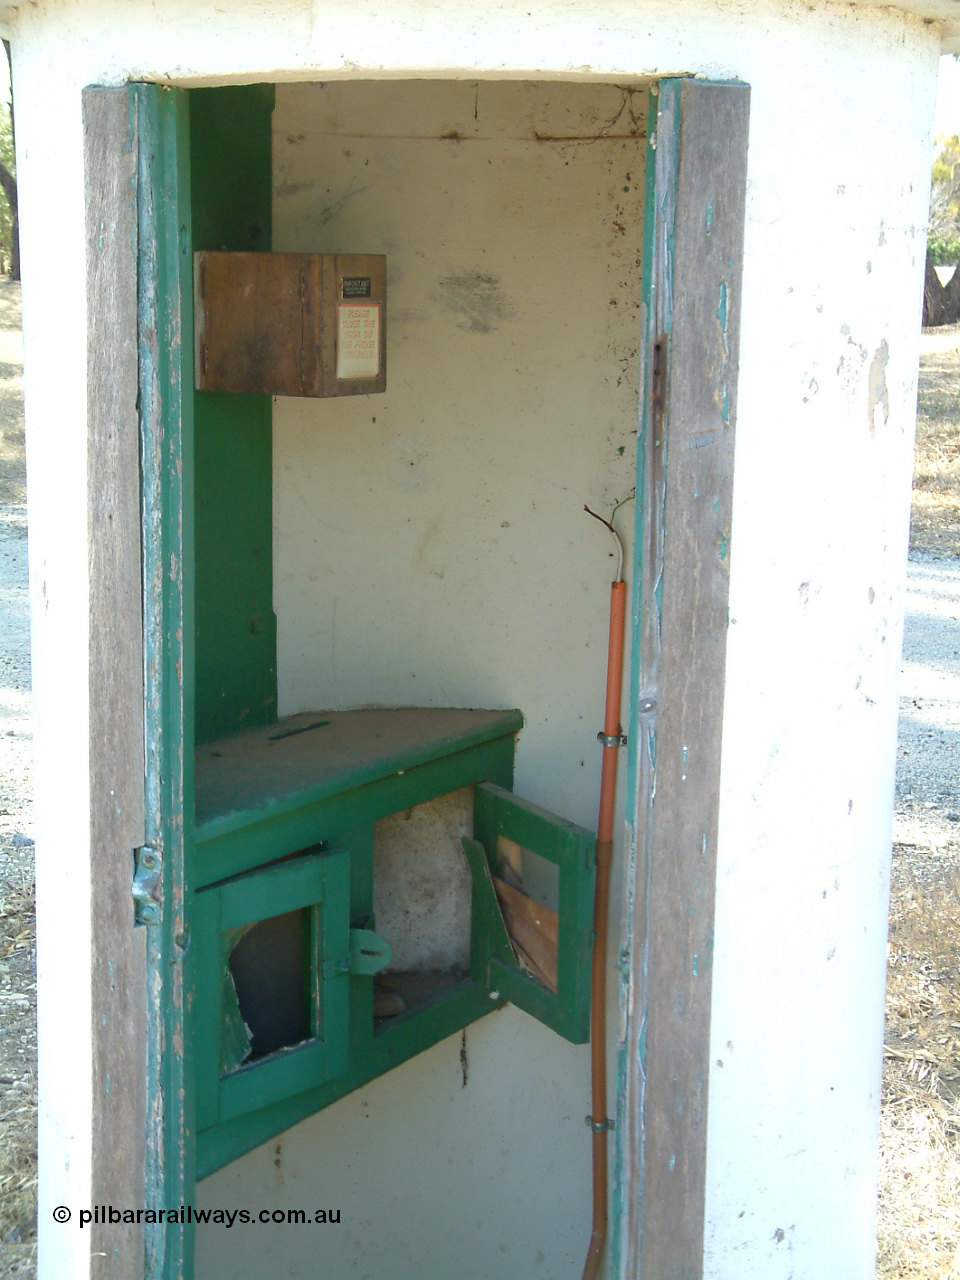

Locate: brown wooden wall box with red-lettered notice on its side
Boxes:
[193,252,387,397]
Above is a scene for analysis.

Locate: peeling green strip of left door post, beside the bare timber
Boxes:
[136,77,195,1280]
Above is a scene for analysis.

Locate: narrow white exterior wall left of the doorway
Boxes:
[14,45,92,1277]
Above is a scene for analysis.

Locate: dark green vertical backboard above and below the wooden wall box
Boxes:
[184,84,276,742]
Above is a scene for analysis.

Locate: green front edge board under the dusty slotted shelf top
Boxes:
[196,736,516,887]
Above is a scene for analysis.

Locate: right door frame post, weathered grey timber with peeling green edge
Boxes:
[612,79,750,1280]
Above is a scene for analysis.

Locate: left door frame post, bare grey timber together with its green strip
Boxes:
[82,77,193,1280]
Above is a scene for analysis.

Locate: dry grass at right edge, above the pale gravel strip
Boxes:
[910,330,960,557]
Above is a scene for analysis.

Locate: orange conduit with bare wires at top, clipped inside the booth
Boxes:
[582,507,627,1280]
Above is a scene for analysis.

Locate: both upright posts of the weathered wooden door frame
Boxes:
[83,72,749,1280]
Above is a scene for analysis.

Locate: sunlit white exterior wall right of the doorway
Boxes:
[707,37,936,1280]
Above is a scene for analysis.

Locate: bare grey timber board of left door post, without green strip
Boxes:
[83,88,147,1277]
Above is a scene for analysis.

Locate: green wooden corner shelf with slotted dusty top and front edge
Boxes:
[195,707,524,887]
